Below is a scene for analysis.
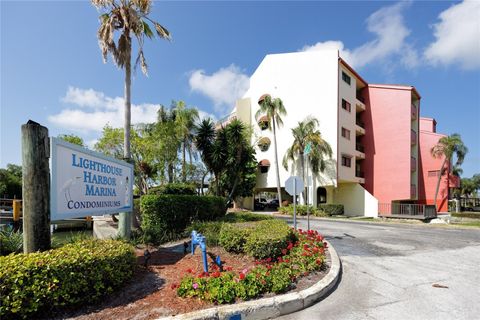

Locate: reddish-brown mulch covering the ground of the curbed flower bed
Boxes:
[46,242,330,320]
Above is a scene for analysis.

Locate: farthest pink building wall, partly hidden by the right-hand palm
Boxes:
[418,118,450,212]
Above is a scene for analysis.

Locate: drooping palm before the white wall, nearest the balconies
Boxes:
[283,117,332,204]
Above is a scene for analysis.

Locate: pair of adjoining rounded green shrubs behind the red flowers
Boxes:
[219,220,295,259]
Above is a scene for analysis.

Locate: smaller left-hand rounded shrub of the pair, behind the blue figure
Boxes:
[218,223,255,253]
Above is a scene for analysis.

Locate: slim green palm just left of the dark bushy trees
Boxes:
[175,101,199,182]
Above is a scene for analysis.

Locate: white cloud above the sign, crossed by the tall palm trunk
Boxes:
[48,87,159,133]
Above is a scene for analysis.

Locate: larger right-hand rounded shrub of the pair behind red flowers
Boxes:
[244,220,295,259]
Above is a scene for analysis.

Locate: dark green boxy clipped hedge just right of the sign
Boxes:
[140,195,226,244]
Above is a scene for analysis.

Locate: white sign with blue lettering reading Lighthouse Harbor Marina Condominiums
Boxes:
[50,138,133,221]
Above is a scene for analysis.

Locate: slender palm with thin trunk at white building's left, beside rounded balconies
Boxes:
[255,94,287,206]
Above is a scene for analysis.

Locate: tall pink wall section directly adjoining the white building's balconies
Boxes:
[362,85,412,203]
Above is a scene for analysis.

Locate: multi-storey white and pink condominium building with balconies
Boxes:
[227,50,448,216]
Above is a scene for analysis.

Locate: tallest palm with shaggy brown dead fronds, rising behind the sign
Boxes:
[91,0,170,161]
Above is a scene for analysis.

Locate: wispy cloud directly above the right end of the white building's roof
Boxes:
[301,2,419,68]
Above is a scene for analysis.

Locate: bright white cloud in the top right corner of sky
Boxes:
[424,0,480,70]
